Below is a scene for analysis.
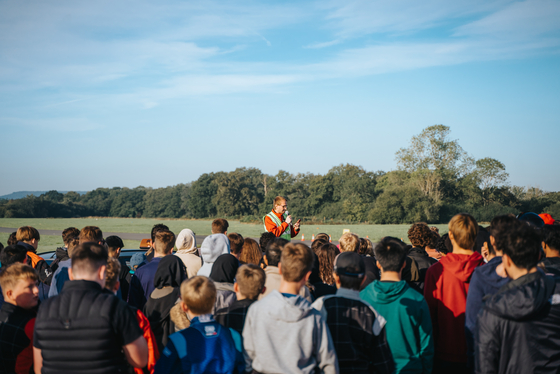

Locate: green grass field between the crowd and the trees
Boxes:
[0,218,447,252]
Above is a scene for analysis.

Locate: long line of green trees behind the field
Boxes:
[0,125,560,224]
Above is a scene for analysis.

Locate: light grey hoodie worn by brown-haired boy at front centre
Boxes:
[243,291,338,374]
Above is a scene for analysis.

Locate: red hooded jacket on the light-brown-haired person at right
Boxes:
[424,252,484,363]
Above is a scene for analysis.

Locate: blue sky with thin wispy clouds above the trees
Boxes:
[0,0,560,195]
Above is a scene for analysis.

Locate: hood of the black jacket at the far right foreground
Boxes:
[485,270,556,320]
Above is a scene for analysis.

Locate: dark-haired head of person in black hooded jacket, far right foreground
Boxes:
[502,224,541,279]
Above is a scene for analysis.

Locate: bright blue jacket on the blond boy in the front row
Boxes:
[154,314,245,374]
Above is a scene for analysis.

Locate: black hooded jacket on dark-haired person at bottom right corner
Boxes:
[475,270,560,374]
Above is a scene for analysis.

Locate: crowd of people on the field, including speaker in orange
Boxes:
[0,198,560,374]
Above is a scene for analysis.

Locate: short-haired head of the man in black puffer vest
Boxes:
[68,242,109,287]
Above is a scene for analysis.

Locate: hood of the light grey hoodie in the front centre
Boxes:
[266,290,313,322]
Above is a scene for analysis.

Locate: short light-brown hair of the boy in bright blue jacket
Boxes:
[181,275,216,314]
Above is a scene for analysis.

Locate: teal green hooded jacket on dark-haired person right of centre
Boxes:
[360,280,434,373]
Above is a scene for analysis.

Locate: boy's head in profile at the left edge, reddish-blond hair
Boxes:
[0,262,39,309]
